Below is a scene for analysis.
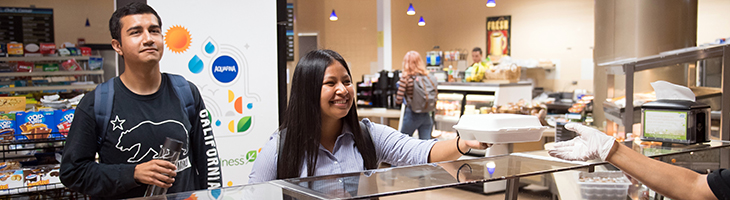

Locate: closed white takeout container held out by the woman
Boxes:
[454,114,547,143]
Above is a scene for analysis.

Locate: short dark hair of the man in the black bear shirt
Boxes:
[109,2,162,42]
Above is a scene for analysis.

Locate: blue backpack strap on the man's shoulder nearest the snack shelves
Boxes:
[94,77,117,152]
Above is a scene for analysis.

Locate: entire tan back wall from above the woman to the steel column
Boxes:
[291,0,593,91]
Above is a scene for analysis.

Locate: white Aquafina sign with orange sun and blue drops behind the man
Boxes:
[147,0,279,187]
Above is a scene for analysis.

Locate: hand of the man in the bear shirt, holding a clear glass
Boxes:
[134,160,177,188]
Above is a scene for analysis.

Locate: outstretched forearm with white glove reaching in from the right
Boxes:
[548,123,730,199]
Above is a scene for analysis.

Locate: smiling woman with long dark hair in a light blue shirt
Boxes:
[248,50,489,184]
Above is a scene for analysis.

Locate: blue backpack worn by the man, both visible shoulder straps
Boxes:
[94,74,195,152]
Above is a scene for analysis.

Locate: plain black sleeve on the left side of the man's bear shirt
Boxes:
[60,91,140,197]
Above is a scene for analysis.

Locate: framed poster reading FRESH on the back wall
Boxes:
[487,15,512,61]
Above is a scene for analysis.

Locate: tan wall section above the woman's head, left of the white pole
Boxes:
[288,0,378,81]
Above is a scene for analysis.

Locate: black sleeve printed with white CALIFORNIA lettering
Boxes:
[190,83,223,190]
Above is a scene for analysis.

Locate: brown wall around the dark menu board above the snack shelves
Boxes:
[0,0,114,46]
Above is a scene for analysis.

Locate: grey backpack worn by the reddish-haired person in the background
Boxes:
[406,75,438,113]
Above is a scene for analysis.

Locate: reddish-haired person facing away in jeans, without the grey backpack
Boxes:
[396,51,433,140]
